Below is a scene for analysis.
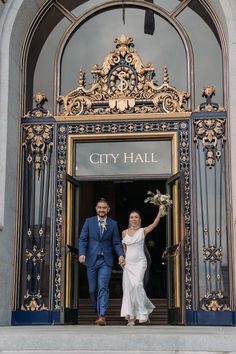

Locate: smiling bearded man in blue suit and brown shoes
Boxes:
[79,198,125,326]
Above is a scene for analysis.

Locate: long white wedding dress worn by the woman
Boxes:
[121,228,155,322]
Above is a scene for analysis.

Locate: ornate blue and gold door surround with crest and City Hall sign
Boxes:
[13,35,233,324]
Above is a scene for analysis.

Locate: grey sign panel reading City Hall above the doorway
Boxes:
[75,140,172,177]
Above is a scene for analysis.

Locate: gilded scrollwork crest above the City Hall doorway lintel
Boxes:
[58,35,189,117]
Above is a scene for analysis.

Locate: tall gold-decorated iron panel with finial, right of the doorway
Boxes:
[193,98,230,311]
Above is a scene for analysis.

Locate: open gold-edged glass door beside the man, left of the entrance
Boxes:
[61,174,79,324]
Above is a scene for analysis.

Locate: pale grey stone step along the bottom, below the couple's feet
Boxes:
[0,326,236,354]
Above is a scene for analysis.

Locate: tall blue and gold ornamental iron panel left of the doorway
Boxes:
[21,124,53,311]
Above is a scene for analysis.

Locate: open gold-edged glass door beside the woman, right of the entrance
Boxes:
[164,171,185,324]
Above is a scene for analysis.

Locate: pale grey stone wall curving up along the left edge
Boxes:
[0,0,43,325]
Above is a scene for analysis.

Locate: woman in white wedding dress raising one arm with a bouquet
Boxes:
[121,206,163,326]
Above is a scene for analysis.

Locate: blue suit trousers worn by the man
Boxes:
[87,256,112,316]
